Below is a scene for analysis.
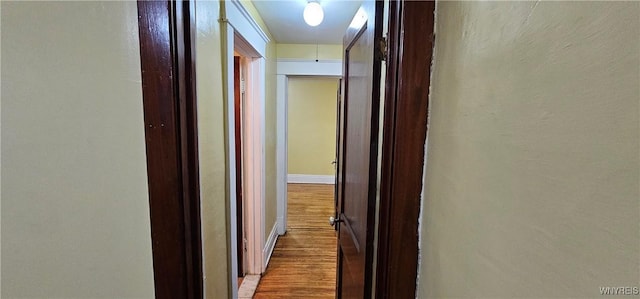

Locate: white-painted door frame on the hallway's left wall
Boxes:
[219,0,270,296]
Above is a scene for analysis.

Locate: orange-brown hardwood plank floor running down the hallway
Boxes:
[253,184,336,299]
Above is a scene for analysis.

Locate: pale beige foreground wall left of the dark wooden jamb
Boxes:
[1,1,154,298]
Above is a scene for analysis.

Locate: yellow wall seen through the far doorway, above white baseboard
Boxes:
[287,77,338,175]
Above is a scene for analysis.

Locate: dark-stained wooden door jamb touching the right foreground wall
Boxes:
[376,1,435,298]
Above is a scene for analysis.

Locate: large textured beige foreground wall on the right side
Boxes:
[418,1,640,298]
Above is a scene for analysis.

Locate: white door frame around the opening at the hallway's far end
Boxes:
[276,59,342,235]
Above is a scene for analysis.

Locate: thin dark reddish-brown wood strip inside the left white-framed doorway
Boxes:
[233,56,244,276]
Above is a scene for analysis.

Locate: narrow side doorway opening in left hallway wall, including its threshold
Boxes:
[230,49,264,295]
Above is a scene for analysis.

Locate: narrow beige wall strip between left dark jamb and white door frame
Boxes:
[196,1,233,298]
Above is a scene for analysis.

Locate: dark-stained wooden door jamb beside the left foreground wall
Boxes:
[138,1,202,298]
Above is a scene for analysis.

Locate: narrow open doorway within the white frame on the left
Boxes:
[229,38,265,277]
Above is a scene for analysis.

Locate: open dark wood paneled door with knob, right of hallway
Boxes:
[336,0,383,298]
